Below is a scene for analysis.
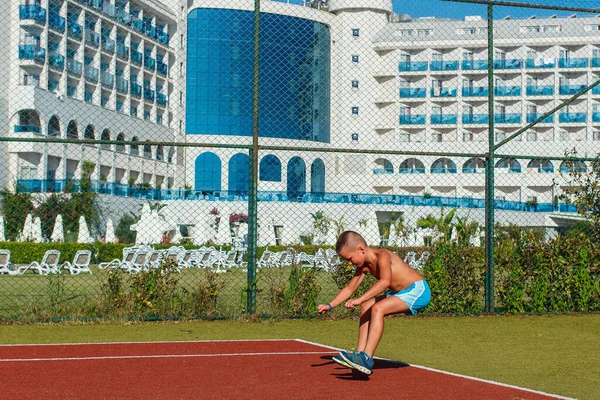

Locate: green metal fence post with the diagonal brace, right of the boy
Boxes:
[485,4,494,312]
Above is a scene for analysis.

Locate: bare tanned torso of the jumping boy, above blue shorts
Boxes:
[357,248,423,292]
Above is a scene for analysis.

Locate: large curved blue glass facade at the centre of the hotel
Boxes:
[186,8,331,143]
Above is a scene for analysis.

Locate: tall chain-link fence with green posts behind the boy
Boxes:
[0,0,600,320]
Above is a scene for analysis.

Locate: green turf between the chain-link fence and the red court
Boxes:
[0,313,600,400]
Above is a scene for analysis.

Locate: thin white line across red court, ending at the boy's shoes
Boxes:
[0,351,335,363]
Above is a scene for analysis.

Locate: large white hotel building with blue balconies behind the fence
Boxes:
[0,0,600,242]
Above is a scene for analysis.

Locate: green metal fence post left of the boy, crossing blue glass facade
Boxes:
[246,0,260,314]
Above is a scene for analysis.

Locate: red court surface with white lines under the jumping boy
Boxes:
[0,340,563,400]
